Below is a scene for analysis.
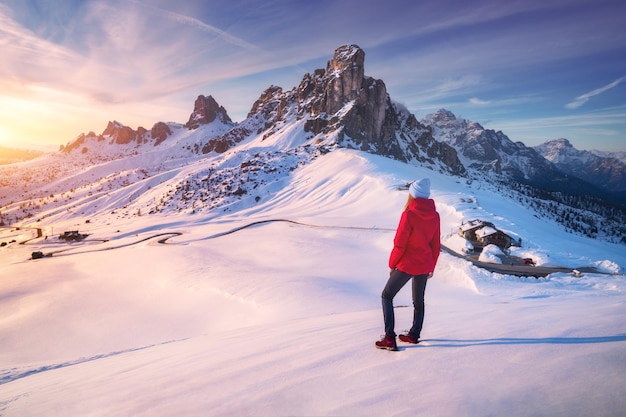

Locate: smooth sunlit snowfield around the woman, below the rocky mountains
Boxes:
[0,148,626,417]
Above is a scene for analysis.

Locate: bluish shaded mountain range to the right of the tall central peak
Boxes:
[422,109,626,204]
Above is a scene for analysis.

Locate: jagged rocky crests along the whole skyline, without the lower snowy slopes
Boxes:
[6,45,626,203]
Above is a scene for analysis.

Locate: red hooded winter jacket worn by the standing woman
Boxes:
[389,198,441,275]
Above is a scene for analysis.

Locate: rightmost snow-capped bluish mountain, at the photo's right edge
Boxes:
[534,139,626,195]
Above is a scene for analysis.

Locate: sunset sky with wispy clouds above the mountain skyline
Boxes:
[0,0,626,151]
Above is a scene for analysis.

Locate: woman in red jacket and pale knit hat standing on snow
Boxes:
[376,178,441,350]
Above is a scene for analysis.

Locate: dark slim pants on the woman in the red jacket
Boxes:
[382,269,428,339]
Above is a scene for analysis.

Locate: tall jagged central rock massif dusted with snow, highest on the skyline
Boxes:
[239,45,465,175]
